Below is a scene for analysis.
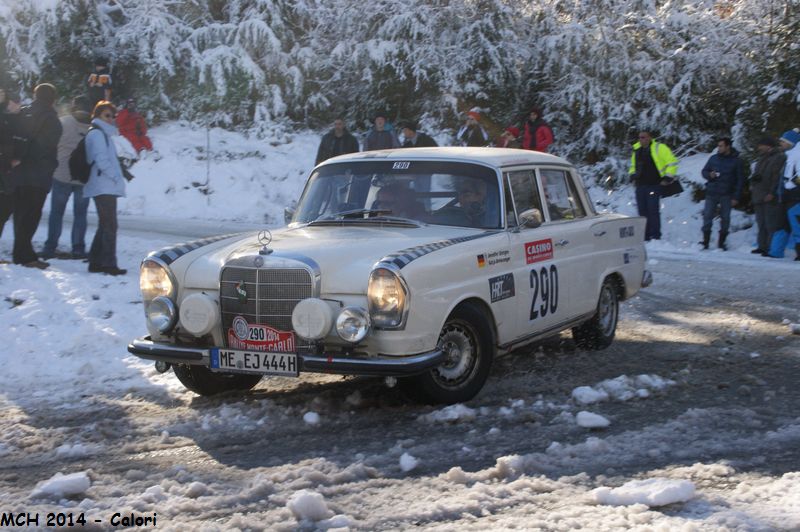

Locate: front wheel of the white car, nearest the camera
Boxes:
[404,303,494,404]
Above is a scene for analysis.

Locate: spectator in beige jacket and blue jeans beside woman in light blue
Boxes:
[41,96,91,259]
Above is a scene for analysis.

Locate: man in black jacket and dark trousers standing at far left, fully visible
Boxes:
[13,83,62,269]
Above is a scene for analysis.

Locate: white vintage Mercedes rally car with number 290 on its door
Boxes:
[128,148,651,403]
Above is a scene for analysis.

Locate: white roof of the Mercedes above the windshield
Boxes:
[323,147,570,166]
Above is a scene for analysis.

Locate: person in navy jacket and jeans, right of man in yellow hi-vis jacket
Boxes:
[700,137,744,251]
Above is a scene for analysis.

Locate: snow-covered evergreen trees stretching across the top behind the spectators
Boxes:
[0,0,800,167]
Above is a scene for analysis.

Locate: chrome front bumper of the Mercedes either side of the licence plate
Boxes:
[128,336,446,377]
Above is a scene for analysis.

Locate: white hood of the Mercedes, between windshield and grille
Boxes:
[180,224,486,294]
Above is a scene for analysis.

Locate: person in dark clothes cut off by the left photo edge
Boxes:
[0,89,21,241]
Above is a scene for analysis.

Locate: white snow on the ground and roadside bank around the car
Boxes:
[0,123,800,530]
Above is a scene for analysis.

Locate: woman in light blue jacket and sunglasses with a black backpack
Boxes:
[83,101,127,275]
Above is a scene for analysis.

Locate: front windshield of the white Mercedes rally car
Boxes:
[292,161,501,229]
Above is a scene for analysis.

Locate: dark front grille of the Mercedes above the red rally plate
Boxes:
[220,266,314,349]
